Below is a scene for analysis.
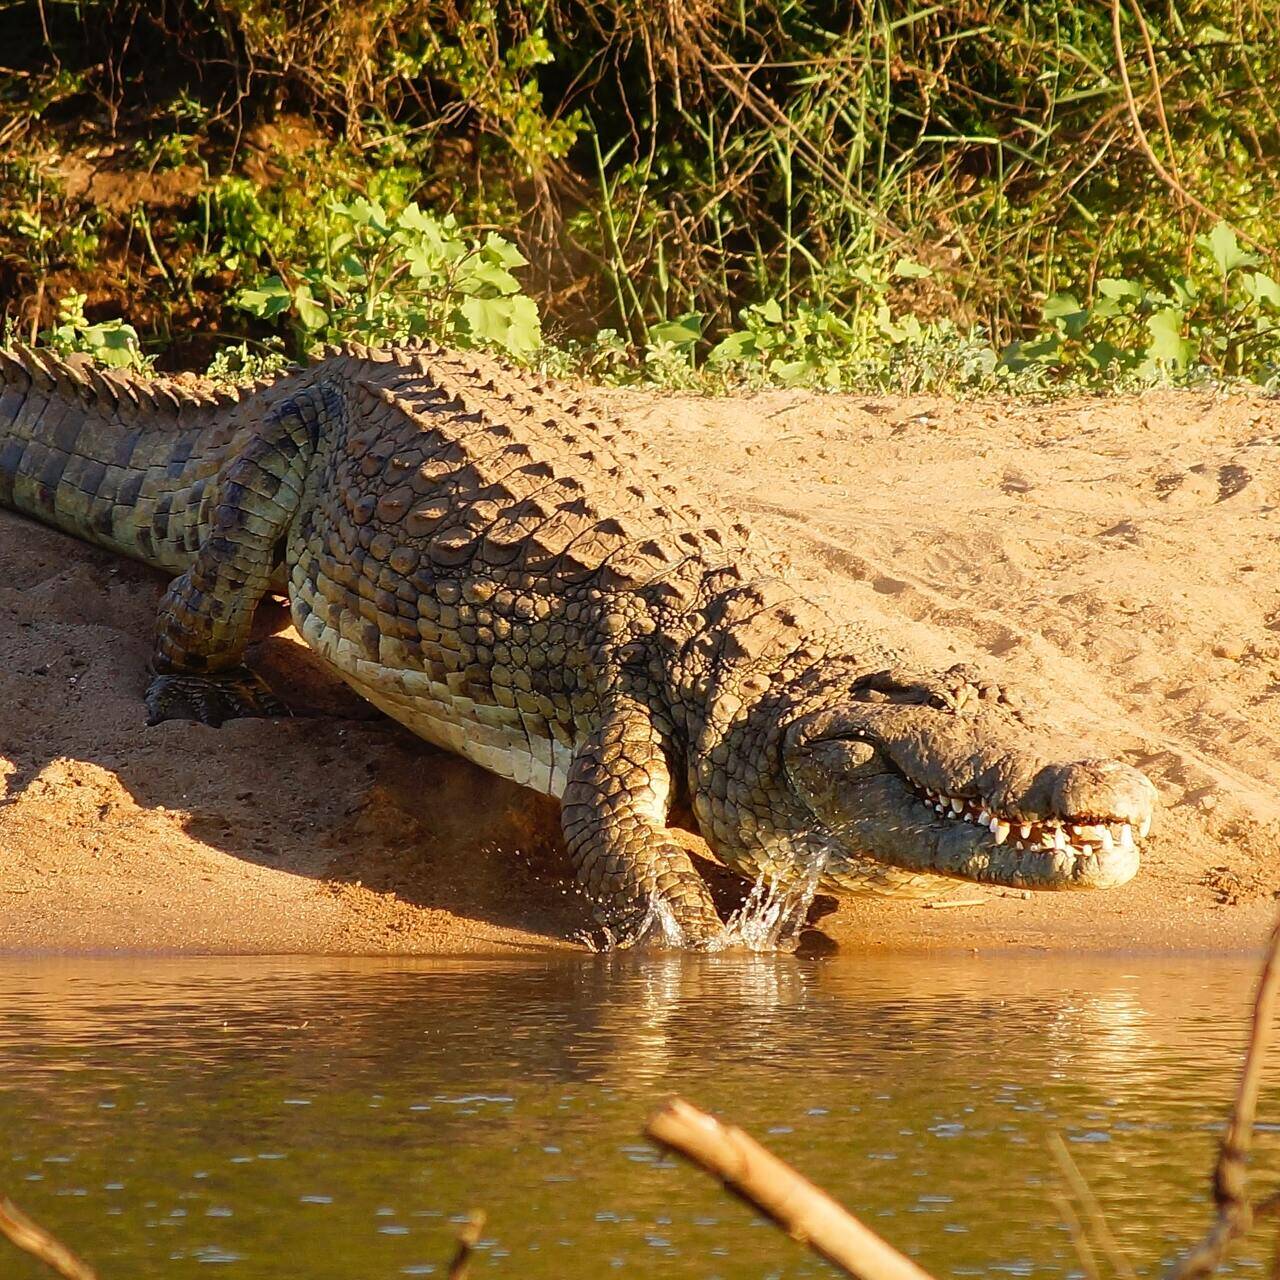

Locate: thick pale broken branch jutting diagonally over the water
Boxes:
[645,1098,932,1280]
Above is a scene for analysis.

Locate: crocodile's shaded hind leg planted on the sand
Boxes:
[146,389,320,726]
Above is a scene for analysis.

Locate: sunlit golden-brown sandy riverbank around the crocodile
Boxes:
[0,392,1280,954]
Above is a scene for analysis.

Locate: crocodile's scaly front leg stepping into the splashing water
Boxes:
[562,703,724,947]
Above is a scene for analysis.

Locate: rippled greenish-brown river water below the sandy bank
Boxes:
[0,954,1280,1280]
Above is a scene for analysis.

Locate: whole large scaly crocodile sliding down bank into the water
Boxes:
[0,343,1156,947]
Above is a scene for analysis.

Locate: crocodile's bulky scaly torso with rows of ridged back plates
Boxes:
[288,349,754,794]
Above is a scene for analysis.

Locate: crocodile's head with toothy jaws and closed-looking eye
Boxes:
[782,668,1156,892]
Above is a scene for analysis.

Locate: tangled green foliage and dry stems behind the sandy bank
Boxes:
[0,0,1280,387]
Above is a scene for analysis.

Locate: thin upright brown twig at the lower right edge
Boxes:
[1165,923,1280,1280]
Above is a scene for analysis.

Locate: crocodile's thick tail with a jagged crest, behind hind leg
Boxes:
[0,348,261,573]
